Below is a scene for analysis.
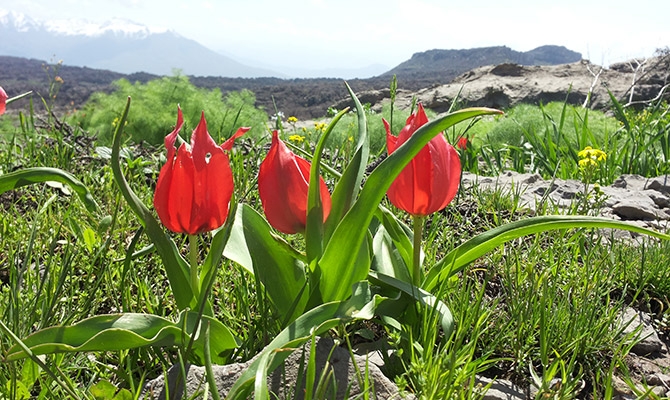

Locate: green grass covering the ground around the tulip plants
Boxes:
[0,79,670,399]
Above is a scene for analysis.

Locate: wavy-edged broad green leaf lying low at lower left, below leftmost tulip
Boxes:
[5,312,237,362]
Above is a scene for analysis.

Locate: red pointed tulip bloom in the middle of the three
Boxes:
[258,131,331,234]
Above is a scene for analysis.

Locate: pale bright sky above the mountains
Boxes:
[0,0,670,74]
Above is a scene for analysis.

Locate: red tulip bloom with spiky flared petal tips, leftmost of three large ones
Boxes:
[154,109,249,235]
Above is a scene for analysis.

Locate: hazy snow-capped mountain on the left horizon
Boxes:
[0,10,282,78]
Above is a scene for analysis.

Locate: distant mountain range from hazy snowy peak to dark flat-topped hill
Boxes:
[0,9,581,83]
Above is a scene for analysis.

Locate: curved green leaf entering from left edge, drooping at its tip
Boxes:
[0,167,99,214]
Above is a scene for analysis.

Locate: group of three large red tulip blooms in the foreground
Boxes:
[154,104,461,235]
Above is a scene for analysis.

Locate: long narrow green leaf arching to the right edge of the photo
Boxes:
[422,215,670,291]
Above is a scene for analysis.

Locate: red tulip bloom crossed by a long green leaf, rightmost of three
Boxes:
[383,103,461,216]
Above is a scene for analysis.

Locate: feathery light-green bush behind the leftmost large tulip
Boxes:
[73,75,267,145]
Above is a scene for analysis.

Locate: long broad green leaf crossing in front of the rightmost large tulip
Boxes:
[319,108,500,302]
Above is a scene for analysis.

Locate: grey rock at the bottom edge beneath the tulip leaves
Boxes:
[140,338,414,400]
